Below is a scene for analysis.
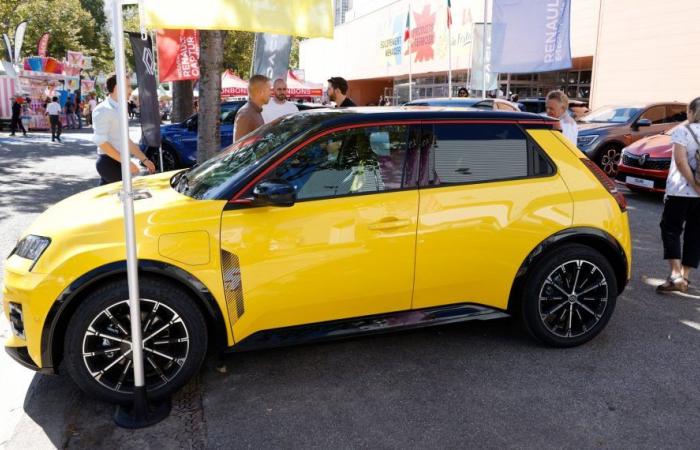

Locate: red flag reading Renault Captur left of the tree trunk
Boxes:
[156,30,199,82]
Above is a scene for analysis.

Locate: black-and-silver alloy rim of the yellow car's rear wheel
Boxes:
[538,260,609,338]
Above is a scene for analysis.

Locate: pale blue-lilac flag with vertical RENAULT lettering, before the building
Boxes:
[491,0,571,73]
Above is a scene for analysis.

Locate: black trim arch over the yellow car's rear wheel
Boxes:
[508,227,629,314]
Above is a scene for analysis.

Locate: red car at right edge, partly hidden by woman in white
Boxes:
[615,124,682,192]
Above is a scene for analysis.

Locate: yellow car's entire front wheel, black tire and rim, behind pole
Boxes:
[64,278,207,404]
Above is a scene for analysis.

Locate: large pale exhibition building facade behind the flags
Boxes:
[300,0,700,107]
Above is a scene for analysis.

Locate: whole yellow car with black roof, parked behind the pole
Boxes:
[3,108,631,402]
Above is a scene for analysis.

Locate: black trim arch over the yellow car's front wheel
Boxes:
[41,259,227,372]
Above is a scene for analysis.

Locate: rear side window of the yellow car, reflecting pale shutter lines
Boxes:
[423,124,554,186]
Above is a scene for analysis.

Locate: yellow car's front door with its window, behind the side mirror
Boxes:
[221,125,418,341]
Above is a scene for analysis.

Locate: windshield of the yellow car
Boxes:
[171,112,328,199]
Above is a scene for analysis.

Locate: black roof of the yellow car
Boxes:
[297,106,552,127]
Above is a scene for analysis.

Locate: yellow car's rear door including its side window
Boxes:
[413,123,573,309]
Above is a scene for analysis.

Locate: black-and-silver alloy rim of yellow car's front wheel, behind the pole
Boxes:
[82,299,190,393]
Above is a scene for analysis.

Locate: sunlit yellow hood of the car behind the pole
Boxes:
[25,172,226,242]
